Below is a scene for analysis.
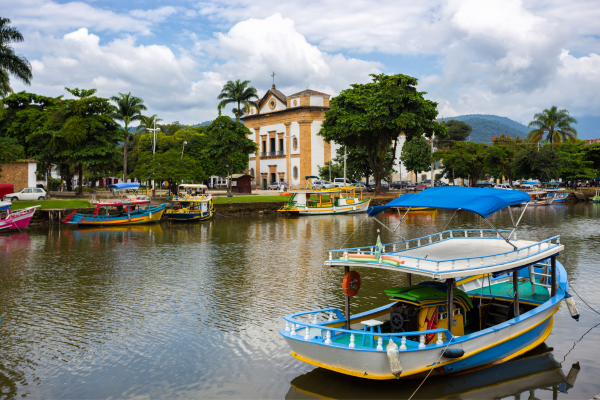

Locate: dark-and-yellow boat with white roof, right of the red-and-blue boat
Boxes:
[165,184,214,222]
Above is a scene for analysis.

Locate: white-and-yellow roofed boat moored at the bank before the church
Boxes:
[278,187,372,215]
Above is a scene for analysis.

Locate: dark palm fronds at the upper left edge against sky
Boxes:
[0,17,33,85]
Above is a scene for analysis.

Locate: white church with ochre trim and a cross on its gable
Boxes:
[241,84,337,189]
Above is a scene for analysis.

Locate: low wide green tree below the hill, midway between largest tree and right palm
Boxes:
[433,142,488,186]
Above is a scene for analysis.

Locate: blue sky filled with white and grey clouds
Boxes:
[0,0,600,124]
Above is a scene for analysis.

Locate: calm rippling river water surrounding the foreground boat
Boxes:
[0,204,600,399]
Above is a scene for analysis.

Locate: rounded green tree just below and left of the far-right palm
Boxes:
[513,144,562,182]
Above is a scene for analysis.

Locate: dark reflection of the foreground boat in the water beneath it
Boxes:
[285,344,580,400]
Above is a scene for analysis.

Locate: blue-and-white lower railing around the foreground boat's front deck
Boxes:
[283,308,454,351]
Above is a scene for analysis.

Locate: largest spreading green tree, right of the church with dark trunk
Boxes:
[319,74,447,191]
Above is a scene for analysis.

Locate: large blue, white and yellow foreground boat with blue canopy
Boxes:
[280,186,579,380]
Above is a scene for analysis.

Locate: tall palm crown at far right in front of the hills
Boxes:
[527,106,577,144]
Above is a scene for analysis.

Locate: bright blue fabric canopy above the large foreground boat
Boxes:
[367,186,530,218]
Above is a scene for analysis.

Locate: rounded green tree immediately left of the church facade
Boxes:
[204,116,258,195]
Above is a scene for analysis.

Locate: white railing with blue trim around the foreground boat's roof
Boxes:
[329,229,560,272]
